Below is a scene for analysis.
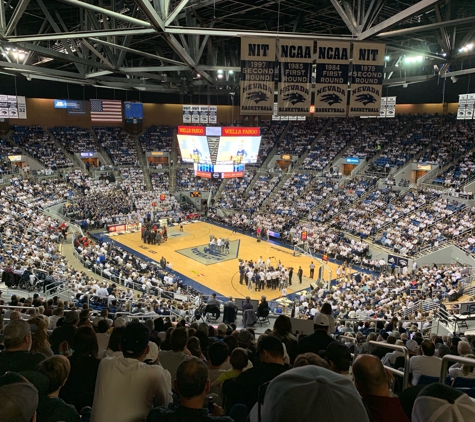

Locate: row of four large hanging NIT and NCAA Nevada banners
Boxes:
[240,37,385,116]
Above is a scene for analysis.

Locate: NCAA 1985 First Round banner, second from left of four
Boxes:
[277,39,313,115]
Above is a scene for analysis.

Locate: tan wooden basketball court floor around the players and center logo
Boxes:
[113,222,346,299]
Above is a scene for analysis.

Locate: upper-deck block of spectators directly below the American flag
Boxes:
[93,126,138,166]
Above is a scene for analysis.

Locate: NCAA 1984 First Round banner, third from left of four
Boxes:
[315,41,350,116]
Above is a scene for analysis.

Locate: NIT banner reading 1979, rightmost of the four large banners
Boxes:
[348,42,386,116]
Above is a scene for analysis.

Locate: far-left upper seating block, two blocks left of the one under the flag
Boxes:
[13,126,73,170]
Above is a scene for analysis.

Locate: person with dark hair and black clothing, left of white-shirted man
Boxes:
[60,326,100,412]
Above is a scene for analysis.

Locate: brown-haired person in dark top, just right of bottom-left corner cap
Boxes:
[37,356,81,422]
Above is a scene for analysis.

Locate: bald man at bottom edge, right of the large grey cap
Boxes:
[352,355,410,422]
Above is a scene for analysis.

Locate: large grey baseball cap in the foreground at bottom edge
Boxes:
[249,365,369,422]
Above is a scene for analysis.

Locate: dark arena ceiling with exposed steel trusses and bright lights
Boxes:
[0,0,475,97]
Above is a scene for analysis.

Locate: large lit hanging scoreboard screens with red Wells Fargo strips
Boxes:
[177,126,261,167]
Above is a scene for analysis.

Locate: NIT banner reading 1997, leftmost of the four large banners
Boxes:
[240,37,275,115]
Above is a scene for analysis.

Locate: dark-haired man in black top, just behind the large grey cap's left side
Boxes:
[222,335,288,411]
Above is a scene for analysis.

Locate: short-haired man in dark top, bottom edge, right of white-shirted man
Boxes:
[147,356,233,422]
